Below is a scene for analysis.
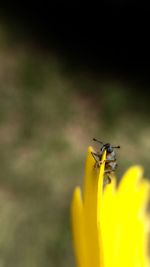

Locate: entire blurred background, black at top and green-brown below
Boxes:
[0,5,150,267]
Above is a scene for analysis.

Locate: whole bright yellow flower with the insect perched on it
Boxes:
[71,147,149,267]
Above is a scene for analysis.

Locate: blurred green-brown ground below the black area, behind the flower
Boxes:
[0,12,150,267]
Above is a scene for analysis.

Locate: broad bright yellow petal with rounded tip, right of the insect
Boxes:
[112,166,148,267]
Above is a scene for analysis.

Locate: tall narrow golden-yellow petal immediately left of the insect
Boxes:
[83,147,101,267]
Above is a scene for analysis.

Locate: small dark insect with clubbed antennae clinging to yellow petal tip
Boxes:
[91,138,120,184]
